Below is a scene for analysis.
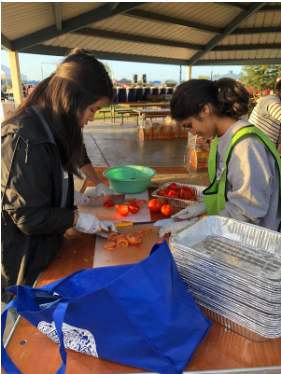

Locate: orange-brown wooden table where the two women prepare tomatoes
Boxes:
[2,168,281,374]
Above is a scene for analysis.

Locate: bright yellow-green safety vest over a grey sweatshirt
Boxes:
[203,125,281,215]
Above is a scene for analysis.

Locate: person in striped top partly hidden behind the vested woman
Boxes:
[249,80,281,149]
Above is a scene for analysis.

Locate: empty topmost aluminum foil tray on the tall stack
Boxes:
[170,216,281,290]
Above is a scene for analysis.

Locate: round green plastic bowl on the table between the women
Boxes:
[103,165,156,193]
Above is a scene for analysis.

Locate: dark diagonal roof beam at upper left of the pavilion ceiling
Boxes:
[12,2,145,51]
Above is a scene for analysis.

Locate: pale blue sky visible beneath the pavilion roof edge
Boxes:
[1,50,241,81]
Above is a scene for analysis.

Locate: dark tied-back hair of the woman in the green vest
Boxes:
[171,78,249,120]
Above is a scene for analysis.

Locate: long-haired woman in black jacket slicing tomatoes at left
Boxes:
[1,49,116,303]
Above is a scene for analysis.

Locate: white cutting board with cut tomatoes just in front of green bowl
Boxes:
[79,187,151,223]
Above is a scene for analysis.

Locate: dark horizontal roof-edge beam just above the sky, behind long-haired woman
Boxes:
[21,44,188,65]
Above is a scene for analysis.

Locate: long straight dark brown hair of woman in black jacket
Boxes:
[5,48,113,177]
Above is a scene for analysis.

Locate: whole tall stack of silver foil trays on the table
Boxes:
[170,216,281,340]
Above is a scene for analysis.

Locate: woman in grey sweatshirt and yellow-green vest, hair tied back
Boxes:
[160,78,281,236]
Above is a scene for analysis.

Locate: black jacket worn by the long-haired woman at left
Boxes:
[1,108,74,302]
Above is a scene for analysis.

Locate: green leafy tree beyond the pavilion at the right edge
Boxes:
[240,65,281,91]
